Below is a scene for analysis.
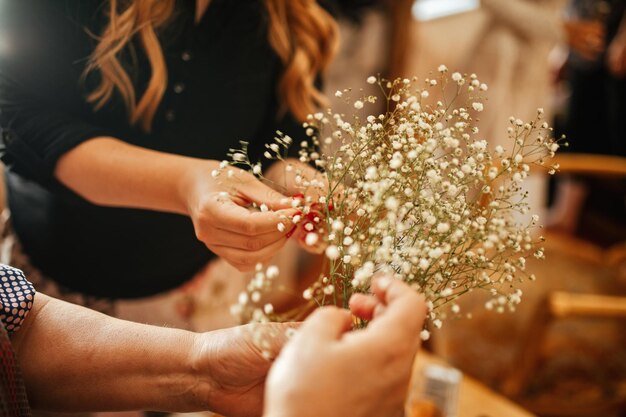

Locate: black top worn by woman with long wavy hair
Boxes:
[0,0,310,298]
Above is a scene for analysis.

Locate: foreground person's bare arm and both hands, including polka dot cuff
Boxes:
[0,265,426,417]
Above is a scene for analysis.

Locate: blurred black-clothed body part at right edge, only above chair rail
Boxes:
[563,0,626,156]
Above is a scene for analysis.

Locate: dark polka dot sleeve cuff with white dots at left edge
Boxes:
[0,264,35,334]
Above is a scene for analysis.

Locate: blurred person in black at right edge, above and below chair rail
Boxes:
[549,0,626,237]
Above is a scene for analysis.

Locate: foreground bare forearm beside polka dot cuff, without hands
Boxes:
[13,294,209,411]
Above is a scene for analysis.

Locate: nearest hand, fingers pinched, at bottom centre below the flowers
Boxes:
[264,277,426,417]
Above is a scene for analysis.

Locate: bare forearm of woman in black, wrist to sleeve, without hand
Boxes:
[55,138,218,214]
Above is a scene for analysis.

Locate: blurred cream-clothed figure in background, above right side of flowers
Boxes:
[462,0,565,150]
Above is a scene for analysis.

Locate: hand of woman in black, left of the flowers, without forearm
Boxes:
[182,161,296,271]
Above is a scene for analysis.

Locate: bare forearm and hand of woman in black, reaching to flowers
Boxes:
[55,137,295,271]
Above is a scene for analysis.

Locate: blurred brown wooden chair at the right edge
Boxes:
[502,154,626,416]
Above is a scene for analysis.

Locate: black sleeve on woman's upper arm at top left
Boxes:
[0,0,111,185]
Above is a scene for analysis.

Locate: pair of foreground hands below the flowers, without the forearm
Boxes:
[195,277,426,417]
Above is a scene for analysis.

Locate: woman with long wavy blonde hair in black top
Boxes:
[0,0,336,318]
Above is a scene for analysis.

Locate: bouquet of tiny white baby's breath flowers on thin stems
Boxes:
[222,65,559,339]
